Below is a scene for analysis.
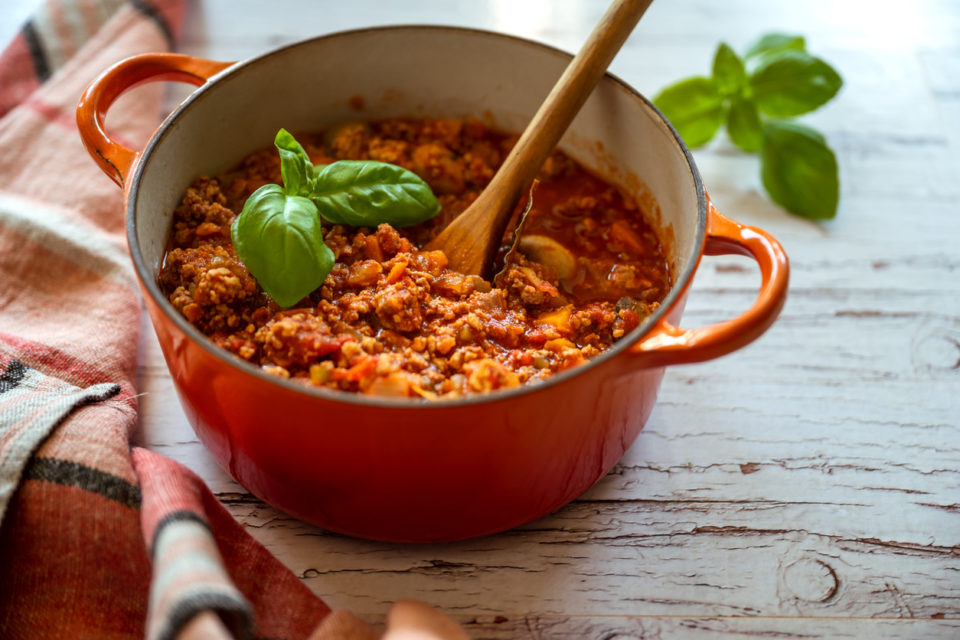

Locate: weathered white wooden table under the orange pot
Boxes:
[122,0,960,640]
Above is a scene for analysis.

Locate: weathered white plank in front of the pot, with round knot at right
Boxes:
[221,494,960,618]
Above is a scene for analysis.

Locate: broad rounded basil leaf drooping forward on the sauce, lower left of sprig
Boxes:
[230,184,334,307]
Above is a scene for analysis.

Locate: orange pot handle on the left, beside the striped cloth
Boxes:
[77,53,234,189]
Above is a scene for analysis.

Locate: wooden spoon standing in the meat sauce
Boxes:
[426,0,653,277]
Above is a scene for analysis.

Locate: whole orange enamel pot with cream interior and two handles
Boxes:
[77,26,788,542]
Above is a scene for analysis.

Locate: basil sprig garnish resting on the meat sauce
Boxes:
[230,129,440,307]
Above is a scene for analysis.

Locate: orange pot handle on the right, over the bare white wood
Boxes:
[630,200,790,367]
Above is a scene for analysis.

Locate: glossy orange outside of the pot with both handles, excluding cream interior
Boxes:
[77,37,788,542]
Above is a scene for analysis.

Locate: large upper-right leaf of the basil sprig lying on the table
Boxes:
[750,50,843,118]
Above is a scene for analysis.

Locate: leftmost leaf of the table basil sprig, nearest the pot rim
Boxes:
[653,76,723,148]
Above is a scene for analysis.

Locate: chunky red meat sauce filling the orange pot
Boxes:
[159,119,671,399]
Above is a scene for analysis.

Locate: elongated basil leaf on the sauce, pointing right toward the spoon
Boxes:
[310,160,440,227]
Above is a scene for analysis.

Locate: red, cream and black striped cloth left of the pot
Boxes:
[0,0,466,640]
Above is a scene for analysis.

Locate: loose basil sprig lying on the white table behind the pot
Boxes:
[653,33,843,219]
